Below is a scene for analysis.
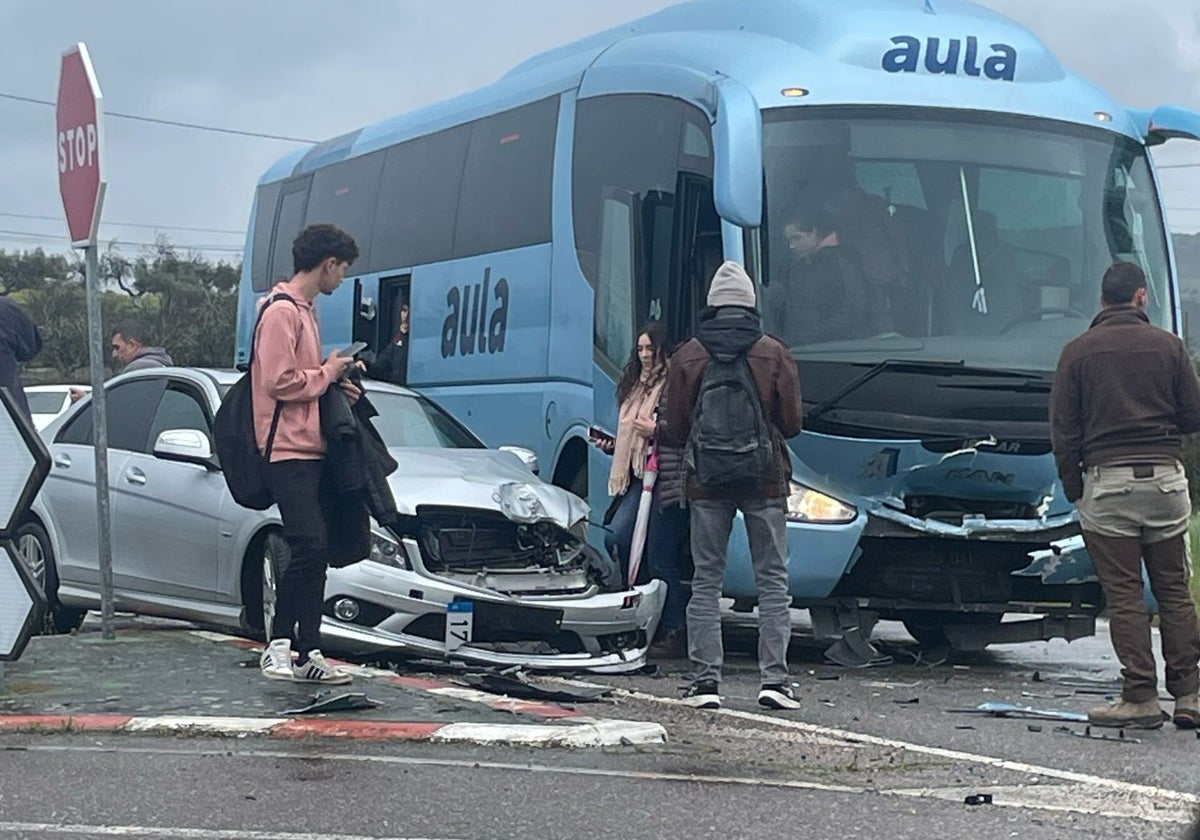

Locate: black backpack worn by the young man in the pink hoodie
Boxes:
[212,294,295,510]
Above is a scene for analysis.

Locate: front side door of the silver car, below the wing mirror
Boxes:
[113,378,226,601]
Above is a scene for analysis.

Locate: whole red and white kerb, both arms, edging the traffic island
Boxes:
[0,630,667,748]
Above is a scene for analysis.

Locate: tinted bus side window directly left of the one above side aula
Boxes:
[370,126,470,271]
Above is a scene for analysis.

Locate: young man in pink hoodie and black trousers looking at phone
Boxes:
[251,224,361,685]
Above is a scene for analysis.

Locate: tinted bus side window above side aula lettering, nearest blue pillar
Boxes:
[454,96,558,257]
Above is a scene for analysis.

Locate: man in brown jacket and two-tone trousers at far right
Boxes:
[1050,262,1200,730]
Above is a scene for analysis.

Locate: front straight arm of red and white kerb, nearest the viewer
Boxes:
[0,714,666,746]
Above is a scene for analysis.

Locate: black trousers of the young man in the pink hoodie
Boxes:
[268,461,330,662]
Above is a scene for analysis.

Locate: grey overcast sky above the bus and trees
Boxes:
[0,0,1200,265]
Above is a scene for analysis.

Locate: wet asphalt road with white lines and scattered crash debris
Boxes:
[0,609,1200,840]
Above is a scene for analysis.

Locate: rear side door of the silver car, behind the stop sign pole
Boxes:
[41,378,166,593]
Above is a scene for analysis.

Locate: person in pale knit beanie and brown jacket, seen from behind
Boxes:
[660,262,803,709]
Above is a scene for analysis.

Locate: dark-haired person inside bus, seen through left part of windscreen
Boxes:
[768,204,886,344]
